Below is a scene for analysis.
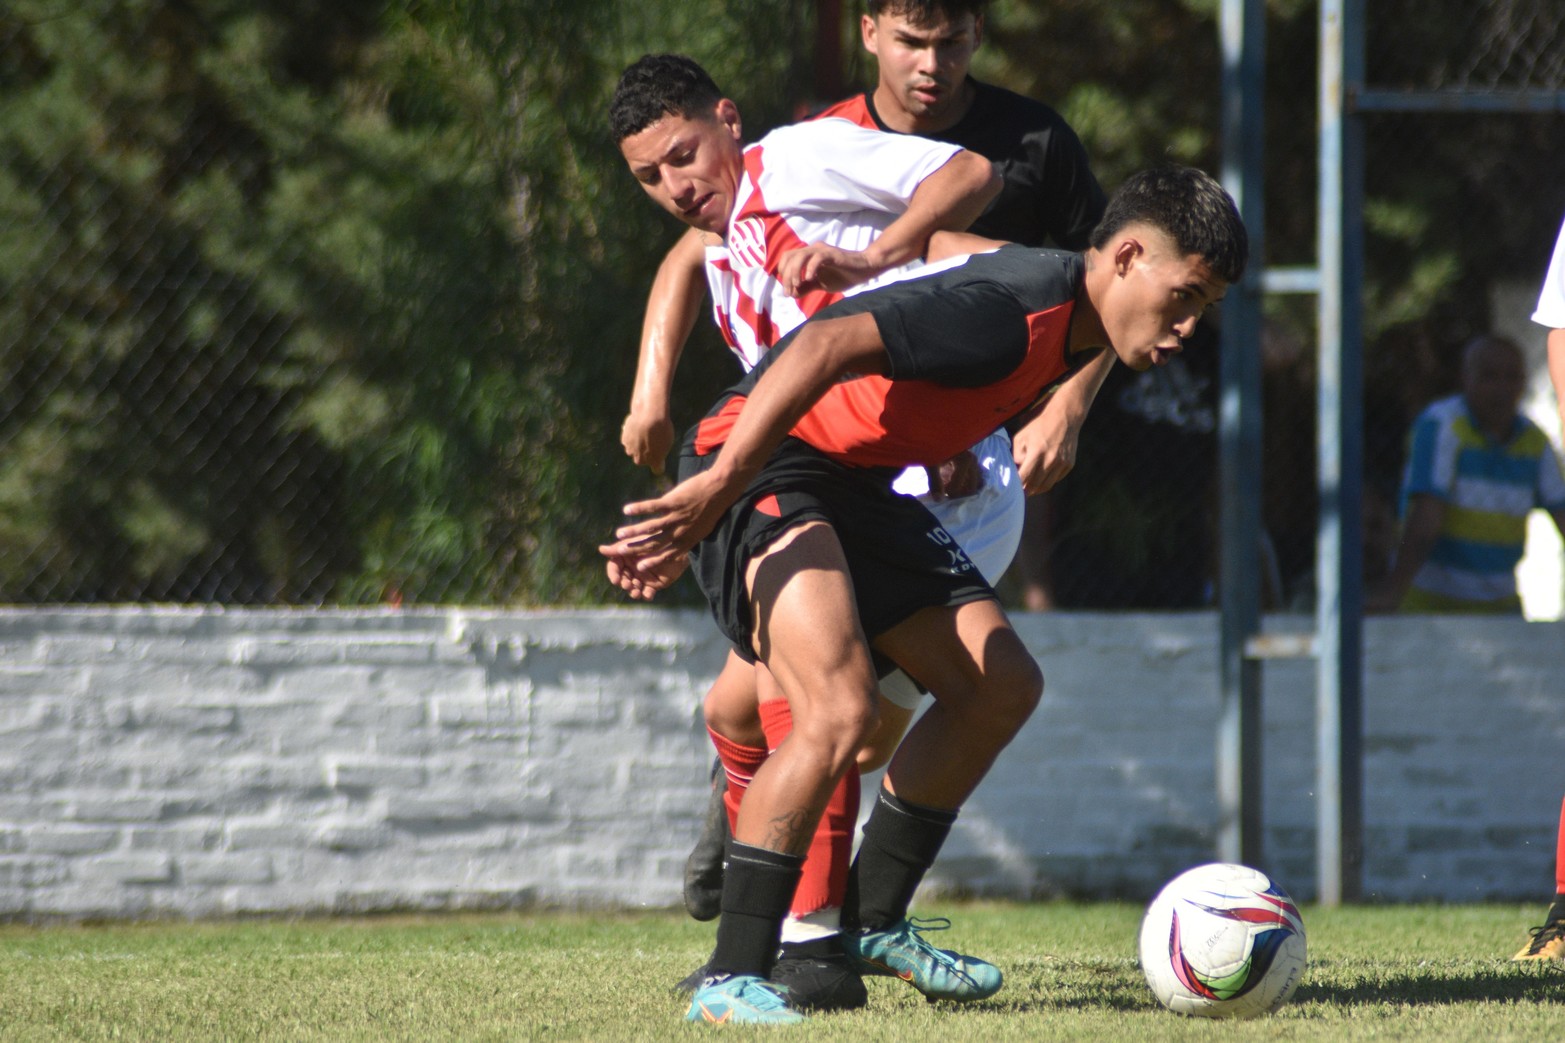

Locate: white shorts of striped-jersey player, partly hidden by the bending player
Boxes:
[881,431,1027,709]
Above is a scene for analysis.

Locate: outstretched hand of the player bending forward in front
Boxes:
[598,473,731,600]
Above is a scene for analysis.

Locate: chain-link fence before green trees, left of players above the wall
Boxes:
[0,0,672,605]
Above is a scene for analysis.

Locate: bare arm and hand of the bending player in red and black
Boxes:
[598,313,887,573]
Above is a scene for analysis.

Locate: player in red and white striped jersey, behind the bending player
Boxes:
[617,56,1022,1005]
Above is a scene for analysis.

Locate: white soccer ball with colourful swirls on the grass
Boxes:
[1141,863,1307,1018]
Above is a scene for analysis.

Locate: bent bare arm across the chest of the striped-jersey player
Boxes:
[778,152,1002,298]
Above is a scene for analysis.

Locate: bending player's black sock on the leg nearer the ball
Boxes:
[842,789,956,930]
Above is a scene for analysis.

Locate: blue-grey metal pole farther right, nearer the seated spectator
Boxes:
[1316,0,1363,905]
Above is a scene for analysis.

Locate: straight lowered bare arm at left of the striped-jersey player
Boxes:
[620,229,706,475]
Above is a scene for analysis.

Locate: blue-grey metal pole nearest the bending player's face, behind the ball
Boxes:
[1216,0,1266,866]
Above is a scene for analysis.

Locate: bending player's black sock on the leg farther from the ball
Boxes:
[707,841,804,977]
